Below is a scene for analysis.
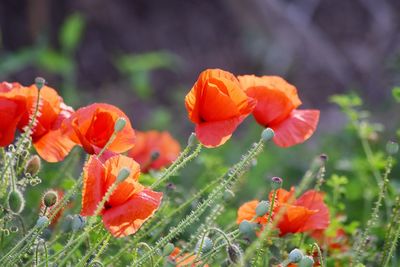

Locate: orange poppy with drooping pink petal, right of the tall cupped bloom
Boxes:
[238,75,319,147]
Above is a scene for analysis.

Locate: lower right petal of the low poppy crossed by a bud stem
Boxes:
[103,189,163,237]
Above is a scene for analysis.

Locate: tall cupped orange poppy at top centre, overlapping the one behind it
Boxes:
[185,69,256,147]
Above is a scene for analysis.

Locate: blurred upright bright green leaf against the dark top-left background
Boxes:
[59,13,85,53]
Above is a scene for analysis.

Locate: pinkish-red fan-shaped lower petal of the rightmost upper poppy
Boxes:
[270,110,319,147]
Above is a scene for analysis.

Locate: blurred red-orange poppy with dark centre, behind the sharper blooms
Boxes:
[128,131,181,173]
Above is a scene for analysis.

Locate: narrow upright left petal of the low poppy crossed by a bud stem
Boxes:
[81,156,106,216]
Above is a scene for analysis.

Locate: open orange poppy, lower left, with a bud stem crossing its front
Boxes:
[81,155,163,237]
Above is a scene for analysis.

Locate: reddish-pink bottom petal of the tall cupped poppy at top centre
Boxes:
[196,116,246,147]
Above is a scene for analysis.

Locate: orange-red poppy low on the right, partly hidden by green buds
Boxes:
[237,187,329,236]
